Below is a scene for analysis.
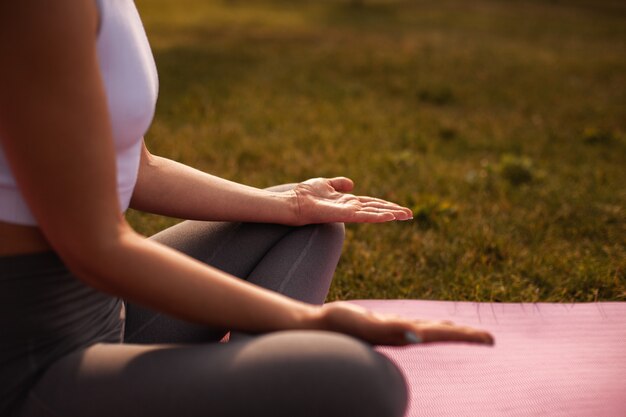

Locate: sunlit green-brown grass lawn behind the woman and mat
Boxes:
[129,0,626,302]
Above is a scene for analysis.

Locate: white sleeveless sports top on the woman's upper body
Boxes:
[0,0,158,225]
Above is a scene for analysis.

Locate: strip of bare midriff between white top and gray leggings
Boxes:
[0,221,52,256]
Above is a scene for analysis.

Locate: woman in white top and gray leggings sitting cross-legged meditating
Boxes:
[0,0,493,417]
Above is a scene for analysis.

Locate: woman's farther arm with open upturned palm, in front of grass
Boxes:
[131,145,412,225]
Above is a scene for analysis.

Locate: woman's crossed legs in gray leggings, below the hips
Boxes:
[19,208,407,417]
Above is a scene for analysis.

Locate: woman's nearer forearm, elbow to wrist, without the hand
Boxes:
[66,224,318,332]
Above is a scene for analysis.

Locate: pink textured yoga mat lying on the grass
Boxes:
[351,300,626,417]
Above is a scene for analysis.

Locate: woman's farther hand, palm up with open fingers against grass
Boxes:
[292,177,413,225]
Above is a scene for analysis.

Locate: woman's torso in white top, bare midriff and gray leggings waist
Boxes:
[0,0,157,415]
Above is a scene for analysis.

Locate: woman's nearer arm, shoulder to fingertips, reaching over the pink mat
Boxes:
[0,0,491,344]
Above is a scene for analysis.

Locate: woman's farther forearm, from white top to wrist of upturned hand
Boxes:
[131,148,297,224]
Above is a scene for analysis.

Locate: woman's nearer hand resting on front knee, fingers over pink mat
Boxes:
[320,302,494,346]
